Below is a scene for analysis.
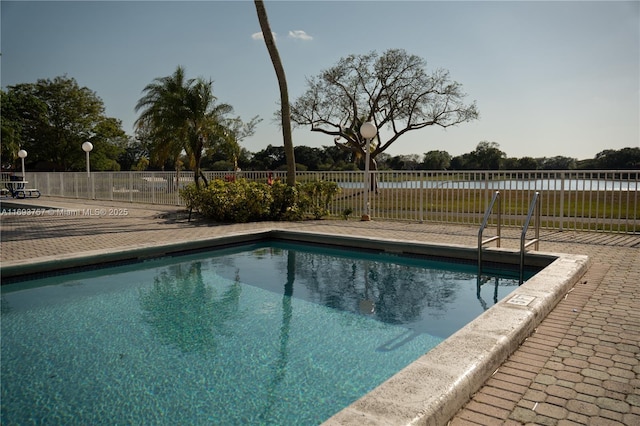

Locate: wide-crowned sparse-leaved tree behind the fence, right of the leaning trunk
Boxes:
[291,49,478,173]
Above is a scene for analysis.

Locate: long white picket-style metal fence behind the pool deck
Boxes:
[22,170,640,233]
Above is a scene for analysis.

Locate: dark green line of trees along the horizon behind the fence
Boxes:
[0,74,640,177]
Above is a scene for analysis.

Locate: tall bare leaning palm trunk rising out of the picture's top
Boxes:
[254,0,296,186]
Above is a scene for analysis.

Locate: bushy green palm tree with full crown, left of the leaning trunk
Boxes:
[135,66,233,188]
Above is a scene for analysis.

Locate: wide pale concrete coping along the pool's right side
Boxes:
[324,245,589,426]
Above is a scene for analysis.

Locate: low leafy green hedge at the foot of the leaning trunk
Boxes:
[180,179,339,223]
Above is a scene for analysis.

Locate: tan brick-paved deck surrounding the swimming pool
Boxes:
[0,197,640,426]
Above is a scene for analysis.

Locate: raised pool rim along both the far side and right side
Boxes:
[0,229,588,425]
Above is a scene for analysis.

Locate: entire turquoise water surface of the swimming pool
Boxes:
[1,242,532,425]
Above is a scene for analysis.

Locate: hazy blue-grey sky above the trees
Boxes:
[0,0,640,159]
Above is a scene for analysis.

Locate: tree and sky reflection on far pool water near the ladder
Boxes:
[212,243,517,337]
